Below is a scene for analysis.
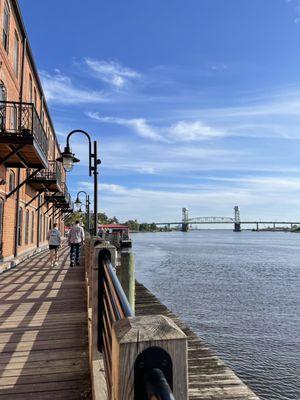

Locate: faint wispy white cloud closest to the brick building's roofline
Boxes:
[40,70,108,105]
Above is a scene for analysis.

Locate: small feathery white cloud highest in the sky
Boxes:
[84,58,141,89]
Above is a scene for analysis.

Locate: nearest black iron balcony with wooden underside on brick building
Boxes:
[0,101,48,168]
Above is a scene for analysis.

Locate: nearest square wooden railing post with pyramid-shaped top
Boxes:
[111,315,188,400]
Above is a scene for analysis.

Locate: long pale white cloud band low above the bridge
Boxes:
[79,179,300,222]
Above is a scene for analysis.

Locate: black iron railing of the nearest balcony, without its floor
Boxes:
[0,101,48,156]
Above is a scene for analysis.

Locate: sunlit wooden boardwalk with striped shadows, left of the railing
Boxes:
[0,247,91,400]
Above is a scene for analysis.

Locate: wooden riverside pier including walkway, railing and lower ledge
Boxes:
[0,238,258,400]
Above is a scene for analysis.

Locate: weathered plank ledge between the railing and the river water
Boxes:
[135,282,259,400]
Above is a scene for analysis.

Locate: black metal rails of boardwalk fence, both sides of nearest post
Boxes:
[98,251,175,400]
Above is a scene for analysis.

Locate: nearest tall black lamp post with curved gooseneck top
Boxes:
[56,129,101,236]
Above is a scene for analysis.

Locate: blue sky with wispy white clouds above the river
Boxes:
[20,0,300,222]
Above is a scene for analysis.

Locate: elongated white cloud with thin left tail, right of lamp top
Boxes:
[87,112,225,143]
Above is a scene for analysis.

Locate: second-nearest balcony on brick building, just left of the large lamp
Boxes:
[27,160,63,192]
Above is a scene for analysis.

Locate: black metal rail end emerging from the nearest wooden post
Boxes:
[144,368,175,400]
